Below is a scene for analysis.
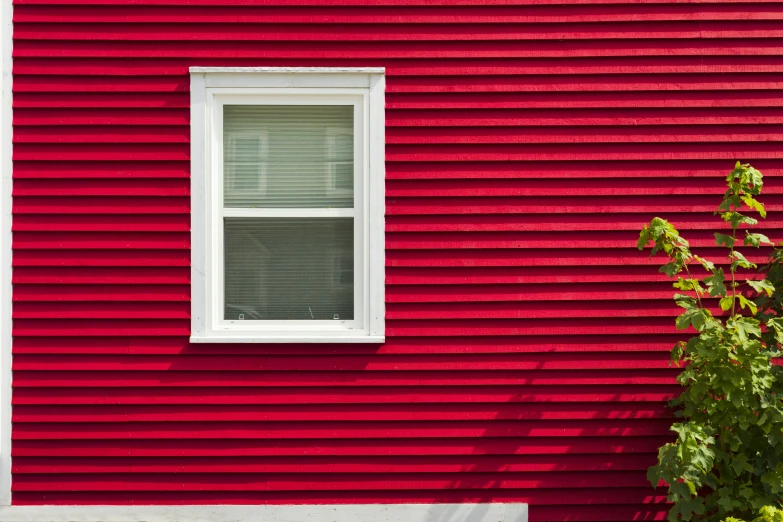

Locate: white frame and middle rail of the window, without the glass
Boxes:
[190,67,385,343]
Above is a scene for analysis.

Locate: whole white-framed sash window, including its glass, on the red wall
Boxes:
[190,67,384,343]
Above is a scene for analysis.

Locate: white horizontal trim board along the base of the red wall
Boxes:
[0,504,527,522]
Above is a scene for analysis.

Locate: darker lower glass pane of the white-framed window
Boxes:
[224,218,354,321]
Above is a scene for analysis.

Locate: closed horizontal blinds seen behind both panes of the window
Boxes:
[223,105,354,321]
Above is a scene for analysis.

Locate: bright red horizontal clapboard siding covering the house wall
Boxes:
[7,0,783,521]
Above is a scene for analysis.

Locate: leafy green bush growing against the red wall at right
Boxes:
[638,162,783,522]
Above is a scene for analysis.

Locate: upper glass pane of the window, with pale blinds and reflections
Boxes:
[223,105,354,208]
